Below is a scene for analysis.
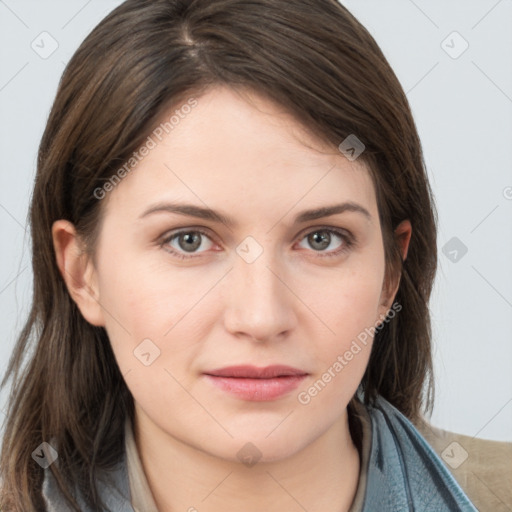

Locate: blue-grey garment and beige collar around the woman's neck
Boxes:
[43,397,486,512]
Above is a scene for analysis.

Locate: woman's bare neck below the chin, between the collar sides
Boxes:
[135,408,360,512]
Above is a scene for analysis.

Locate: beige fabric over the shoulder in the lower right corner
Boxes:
[417,420,512,512]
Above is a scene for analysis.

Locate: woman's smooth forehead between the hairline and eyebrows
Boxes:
[104,87,376,222]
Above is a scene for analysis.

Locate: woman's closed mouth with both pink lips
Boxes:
[203,365,309,402]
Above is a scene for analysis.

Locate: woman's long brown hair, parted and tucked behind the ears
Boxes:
[0,0,437,512]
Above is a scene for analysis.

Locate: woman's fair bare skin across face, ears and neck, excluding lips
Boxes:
[53,87,411,512]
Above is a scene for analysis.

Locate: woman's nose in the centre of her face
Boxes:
[224,245,299,341]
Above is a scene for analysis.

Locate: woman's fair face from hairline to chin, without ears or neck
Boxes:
[79,88,400,460]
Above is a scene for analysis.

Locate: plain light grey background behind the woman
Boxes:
[0,0,512,441]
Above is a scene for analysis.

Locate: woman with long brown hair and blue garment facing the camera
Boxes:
[1,0,504,512]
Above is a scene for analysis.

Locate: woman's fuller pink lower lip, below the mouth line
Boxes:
[205,375,306,402]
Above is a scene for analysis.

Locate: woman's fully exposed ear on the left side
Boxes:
[52,220,105,327]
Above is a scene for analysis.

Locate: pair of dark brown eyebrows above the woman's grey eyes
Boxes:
[139,201,372,227]
